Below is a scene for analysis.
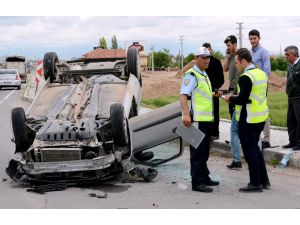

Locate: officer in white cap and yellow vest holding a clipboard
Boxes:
[180,47,220,192]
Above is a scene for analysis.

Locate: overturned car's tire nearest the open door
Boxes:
[110,103,129,147]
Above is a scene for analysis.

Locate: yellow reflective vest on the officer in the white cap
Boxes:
[185,68,214,122]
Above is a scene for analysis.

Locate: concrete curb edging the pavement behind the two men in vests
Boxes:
[211,140,300,169]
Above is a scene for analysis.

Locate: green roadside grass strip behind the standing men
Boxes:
[142,92,288,127]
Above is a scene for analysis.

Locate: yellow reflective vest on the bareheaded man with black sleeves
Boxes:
[235,68,269,123]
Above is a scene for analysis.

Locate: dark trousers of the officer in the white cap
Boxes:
[190,122,212,186]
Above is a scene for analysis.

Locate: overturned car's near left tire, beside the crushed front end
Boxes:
[11,107,30,152]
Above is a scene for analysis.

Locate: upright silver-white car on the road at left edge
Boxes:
[0,69,21,90]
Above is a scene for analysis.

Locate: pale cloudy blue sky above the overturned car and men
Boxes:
[0,16,300,59]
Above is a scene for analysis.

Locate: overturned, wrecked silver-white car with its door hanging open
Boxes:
[6,48,183,182]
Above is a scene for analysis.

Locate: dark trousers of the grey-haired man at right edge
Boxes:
[287,98,300,146]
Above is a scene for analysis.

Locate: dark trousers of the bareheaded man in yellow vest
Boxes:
[238,121,269,185]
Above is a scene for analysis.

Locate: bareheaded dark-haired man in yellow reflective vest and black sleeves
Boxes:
[224,48,271,192]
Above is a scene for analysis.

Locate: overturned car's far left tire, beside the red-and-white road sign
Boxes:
[43,52,59,83]
